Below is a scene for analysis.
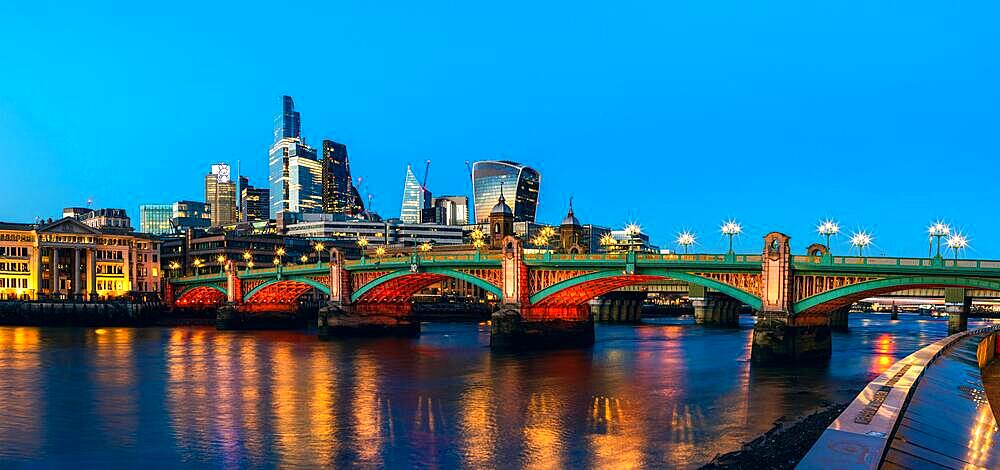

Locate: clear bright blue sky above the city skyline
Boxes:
[0,0,1000,258]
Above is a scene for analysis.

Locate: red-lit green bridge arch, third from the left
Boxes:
[351,267,503,302]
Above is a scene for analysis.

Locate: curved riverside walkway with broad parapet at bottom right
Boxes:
[797,326,1000,469]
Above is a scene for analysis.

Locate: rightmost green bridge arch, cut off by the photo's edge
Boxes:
[792,276,1000,315]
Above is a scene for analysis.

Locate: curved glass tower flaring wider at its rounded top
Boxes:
[472,160,542,223]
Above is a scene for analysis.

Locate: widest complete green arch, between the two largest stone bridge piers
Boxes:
[530,269,761,310]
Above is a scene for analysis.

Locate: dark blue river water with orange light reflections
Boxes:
[0,314,992,468]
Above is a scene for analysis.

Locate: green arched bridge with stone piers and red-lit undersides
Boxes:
[165,232,1000,362]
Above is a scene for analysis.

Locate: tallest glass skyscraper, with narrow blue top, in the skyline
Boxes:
[268,96,323,217]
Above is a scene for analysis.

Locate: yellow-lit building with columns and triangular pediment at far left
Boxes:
[0,217,161,300]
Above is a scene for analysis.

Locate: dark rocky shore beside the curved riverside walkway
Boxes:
[701,402,850,470]
